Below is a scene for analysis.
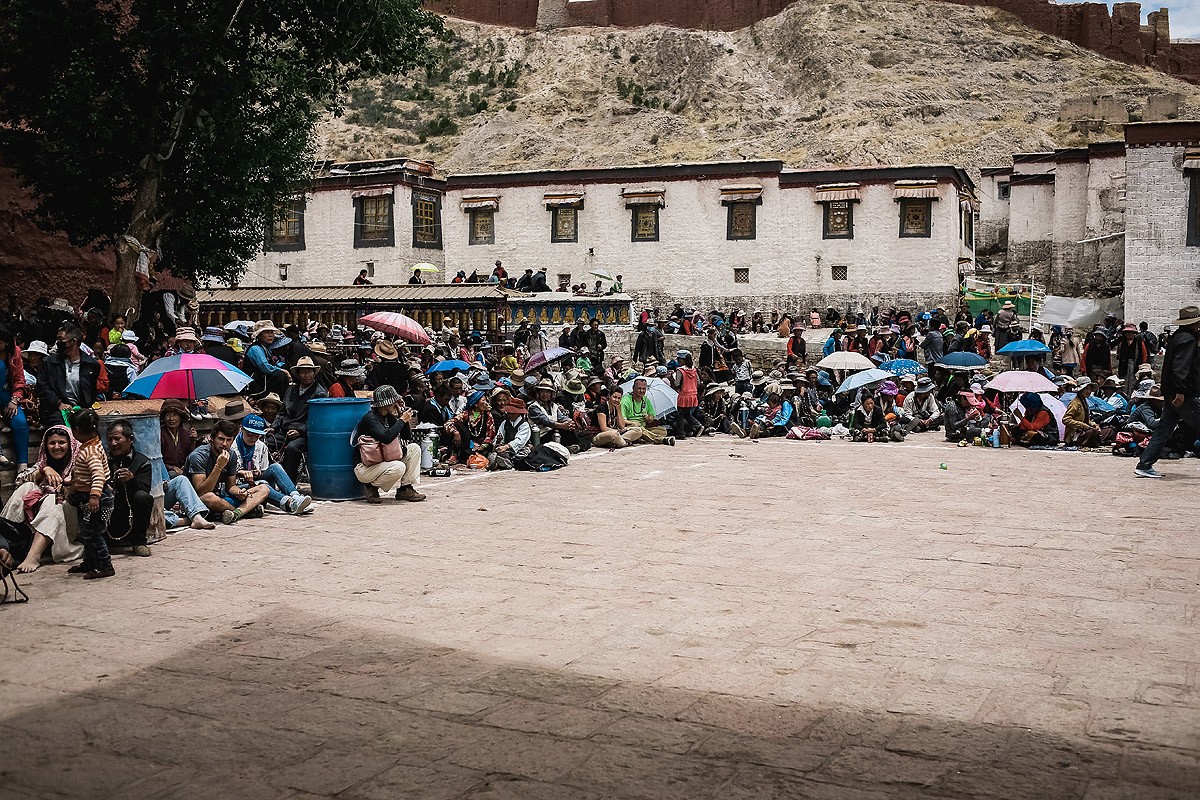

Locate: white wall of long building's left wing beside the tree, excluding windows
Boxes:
[239,184,446,288]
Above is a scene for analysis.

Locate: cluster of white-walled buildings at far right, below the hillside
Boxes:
[978,120,1200,327]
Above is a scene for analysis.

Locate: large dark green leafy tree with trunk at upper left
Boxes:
[0,0,445,313]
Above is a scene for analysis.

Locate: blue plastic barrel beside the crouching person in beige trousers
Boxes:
[308,397,371,500]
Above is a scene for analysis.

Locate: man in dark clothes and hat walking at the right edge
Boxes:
[1134,306,1200,477]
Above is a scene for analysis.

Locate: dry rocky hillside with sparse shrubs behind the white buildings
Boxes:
[322,0,1200,173]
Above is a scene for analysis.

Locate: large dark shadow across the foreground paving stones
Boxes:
[0,609,1200,800]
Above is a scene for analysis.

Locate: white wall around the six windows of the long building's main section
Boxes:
[443,178,970,305]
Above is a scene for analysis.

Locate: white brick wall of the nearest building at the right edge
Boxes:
[1124,145,1200,331]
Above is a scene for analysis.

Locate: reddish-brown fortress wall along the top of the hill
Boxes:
[430,0,1200,83]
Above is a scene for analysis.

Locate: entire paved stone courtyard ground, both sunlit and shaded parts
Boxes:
[0,438,1200,800]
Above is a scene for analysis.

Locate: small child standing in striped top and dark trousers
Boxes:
[67,408,116,581]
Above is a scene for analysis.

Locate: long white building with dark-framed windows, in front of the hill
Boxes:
[240,160,978,311]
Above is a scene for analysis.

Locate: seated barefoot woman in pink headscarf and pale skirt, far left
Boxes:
[2,425,83,572]
